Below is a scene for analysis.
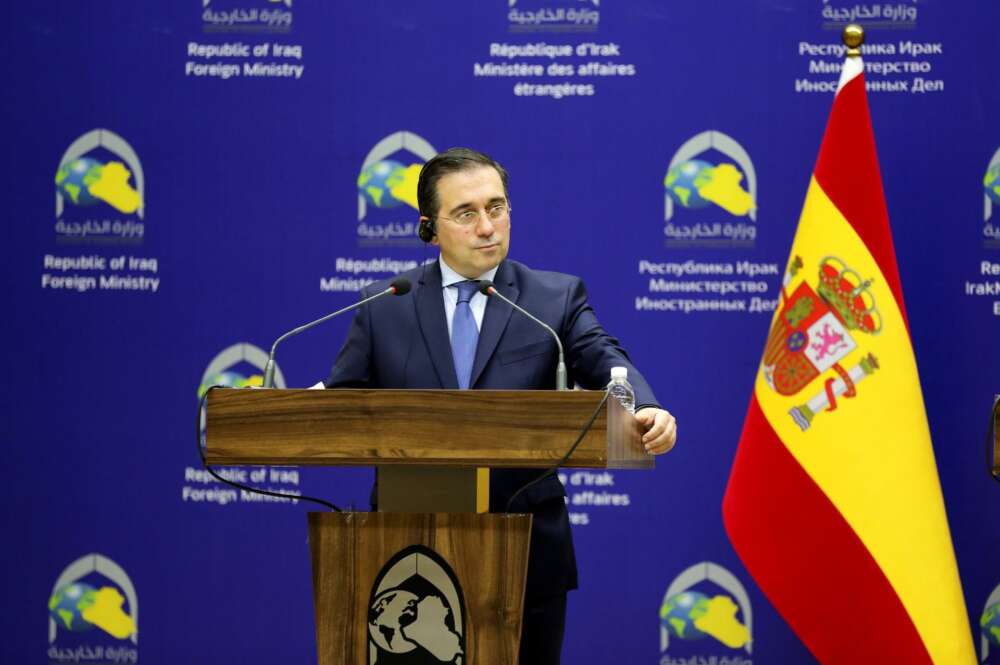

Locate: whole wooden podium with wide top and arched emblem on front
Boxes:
[206,389,654,665]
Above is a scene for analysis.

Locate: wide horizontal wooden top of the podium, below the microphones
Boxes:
[206,389,654,469]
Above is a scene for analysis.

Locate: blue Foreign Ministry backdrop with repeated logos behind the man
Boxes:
[0,0,1000,665]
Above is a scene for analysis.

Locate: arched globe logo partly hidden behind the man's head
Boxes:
[357,131,437,247]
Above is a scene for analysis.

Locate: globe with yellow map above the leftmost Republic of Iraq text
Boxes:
[56,157,142,214]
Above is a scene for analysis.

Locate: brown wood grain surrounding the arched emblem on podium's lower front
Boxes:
[309,513,531,665]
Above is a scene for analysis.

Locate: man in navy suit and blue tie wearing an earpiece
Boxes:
[327,148,677,665]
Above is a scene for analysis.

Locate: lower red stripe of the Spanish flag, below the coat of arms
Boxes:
[722,396,932,665]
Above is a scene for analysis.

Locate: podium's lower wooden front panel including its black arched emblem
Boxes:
[309,513,531,665]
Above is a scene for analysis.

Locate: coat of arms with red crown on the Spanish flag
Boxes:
[761,256,882,432]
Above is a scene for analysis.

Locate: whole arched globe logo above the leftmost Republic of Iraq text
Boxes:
[55,129,146,245]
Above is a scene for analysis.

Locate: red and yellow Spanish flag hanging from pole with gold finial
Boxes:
[722,45,975,665]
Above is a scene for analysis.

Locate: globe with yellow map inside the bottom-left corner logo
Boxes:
[49,582,135,640]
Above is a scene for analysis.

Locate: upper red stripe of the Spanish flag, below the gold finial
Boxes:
[814,74,909,329]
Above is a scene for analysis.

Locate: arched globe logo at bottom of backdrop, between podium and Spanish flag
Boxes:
[660,561,753,665]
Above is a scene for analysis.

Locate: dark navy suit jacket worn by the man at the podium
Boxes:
[327,260,657,603]
